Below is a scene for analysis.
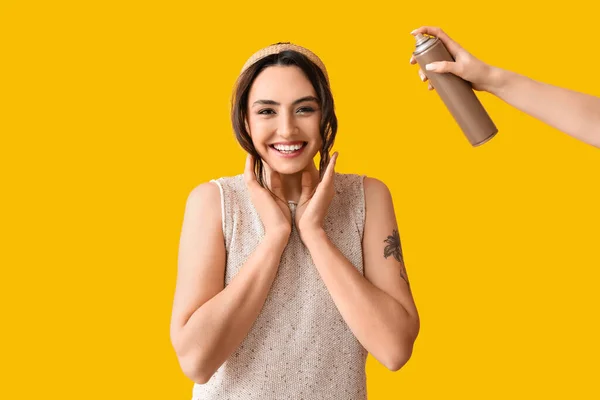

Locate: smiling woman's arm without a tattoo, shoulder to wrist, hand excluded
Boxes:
[171,183,289,384]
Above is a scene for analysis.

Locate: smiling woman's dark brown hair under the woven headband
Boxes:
[231,50,337,187]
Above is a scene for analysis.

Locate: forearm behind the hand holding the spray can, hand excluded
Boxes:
[486,68,600,148]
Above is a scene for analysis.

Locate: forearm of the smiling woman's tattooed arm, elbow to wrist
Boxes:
[303,230,418,370]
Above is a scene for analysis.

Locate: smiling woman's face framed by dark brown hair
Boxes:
[247,65,322,174]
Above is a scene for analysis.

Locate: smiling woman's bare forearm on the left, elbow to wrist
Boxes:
[178,236,287,383]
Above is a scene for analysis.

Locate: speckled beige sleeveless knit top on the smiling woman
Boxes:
[193,173,368,400]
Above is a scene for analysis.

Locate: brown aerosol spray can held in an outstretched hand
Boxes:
[413,33,498,147]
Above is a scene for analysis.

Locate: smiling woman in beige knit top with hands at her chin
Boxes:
[171,43,419,400]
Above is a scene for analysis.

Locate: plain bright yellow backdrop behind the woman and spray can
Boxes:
[0,0,600,400]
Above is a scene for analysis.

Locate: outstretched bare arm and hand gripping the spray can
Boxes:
[410,26,600,148]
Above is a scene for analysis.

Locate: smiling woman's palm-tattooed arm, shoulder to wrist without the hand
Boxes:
[302,173,420,371]
